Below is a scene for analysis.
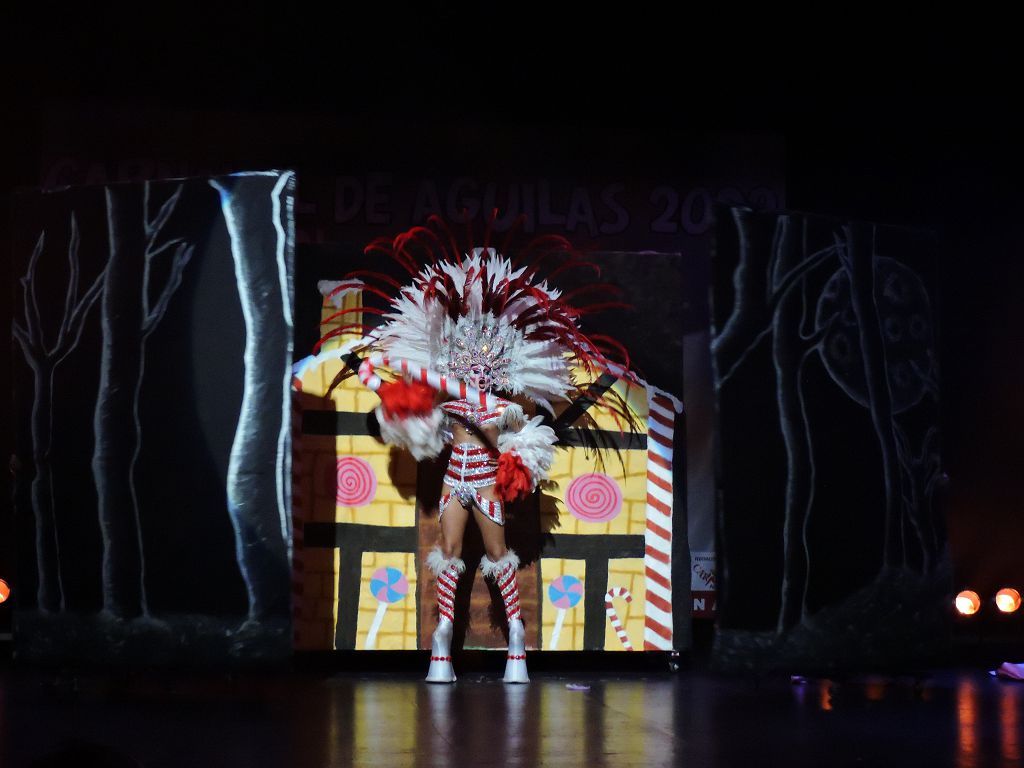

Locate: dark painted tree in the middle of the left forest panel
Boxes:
[92,182,193,617]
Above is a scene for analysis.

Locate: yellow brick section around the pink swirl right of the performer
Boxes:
[543,447,647,535]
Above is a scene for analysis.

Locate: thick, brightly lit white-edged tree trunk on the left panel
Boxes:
[210,172,294,621]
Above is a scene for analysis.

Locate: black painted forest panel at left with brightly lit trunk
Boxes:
[11,171,295,663]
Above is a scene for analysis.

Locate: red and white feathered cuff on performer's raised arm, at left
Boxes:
[375,381,444,461]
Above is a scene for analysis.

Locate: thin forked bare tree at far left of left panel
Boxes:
[11,217,108,611]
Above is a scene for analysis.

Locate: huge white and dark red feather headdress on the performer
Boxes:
[322,217,629,410]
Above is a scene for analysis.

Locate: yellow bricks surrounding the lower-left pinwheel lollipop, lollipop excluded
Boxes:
[355,552,417,650]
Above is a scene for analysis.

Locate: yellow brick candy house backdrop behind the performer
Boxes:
[293,270,689,651]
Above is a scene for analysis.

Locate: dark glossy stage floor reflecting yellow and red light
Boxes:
[0,668,1024,768]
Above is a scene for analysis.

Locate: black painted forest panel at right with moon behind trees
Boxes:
[712,208,950,671]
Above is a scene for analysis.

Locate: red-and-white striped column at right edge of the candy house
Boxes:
[643,387,682,650]
